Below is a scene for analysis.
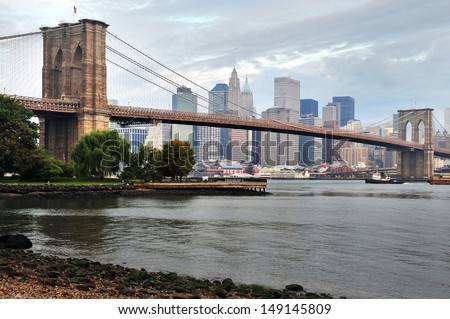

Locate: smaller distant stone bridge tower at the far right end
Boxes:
[397,109,434,181]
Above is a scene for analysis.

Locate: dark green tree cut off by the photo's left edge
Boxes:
[0,95,39,177]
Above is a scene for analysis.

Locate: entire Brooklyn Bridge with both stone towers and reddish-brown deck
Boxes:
[0,19,450,180]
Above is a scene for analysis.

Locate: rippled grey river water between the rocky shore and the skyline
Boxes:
[0,180,450,298]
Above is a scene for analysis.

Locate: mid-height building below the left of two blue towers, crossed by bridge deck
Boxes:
[299,117,323,166]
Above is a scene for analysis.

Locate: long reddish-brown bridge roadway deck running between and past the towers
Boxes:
[13,96,450,158]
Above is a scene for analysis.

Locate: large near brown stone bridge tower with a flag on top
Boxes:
[39,19,109,162]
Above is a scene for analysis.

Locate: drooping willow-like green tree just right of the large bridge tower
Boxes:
[71,131,130,178]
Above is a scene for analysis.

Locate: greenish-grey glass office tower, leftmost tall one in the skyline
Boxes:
[172,86,198,146]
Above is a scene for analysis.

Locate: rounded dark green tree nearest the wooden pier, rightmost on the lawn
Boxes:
[161,140,195,181]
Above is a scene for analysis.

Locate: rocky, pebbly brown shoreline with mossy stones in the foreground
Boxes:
[0,249,332,299]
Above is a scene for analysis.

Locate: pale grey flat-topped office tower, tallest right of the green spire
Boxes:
[274,77,300,113]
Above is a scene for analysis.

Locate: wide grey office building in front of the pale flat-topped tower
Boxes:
[261,108,299,166]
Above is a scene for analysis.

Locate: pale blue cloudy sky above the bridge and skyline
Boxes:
[0,0,450,126]
